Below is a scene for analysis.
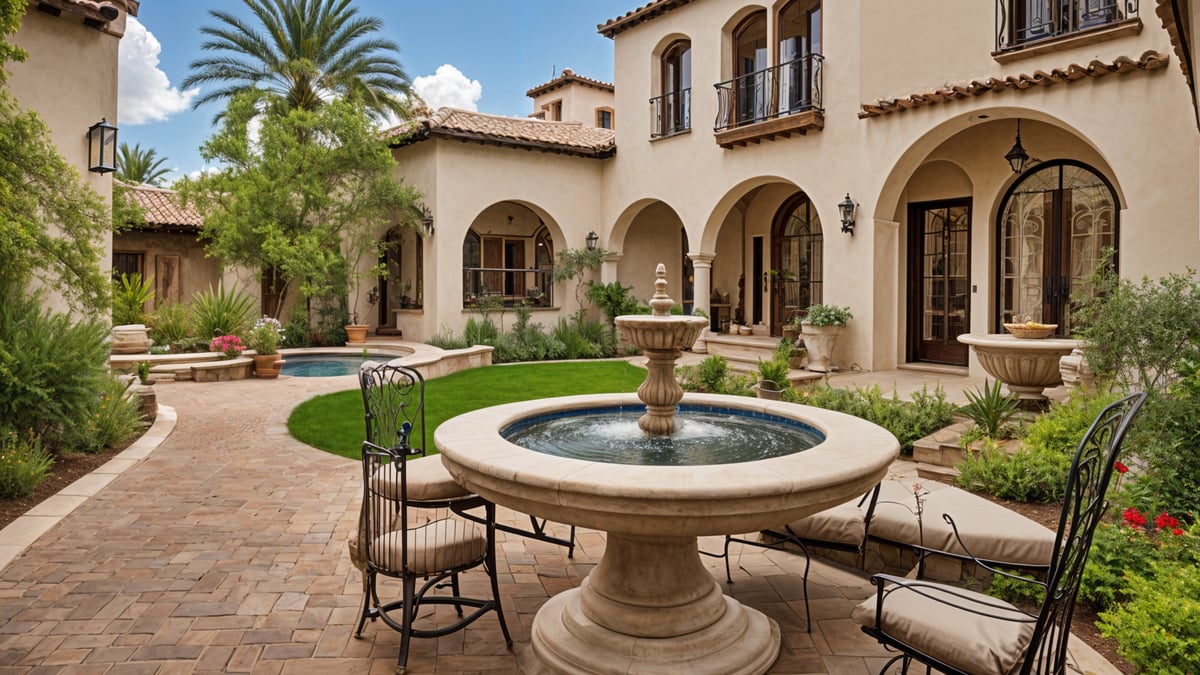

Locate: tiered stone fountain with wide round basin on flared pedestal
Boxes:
[434,265,900,675]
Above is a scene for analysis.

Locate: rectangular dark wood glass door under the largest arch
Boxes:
[908,198,971,365]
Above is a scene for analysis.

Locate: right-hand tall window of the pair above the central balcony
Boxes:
[779,0,821,114]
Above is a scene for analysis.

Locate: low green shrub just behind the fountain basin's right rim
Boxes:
[800,384,956,454]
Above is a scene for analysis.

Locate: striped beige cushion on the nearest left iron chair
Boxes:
[370,518,487,574]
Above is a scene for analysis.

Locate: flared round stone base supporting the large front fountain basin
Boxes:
[532,532,780,674]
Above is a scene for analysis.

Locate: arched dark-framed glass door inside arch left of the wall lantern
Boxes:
[770,192,823,334]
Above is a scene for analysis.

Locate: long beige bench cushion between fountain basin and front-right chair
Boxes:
[870,480,1055,567]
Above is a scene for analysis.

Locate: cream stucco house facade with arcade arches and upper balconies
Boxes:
[381,0,1200,374]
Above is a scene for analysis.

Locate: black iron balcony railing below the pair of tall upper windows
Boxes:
[713,54,824,132]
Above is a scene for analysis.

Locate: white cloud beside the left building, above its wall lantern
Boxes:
[116,17,200,125]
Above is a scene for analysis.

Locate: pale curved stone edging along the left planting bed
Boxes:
[0,405,176,571]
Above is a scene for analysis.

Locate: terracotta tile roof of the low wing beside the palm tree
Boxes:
[384,108,617,159]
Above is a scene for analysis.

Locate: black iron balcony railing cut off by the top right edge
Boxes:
[996,0,1139,52]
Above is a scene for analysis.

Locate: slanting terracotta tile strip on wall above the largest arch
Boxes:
[858,50,1170,119]
